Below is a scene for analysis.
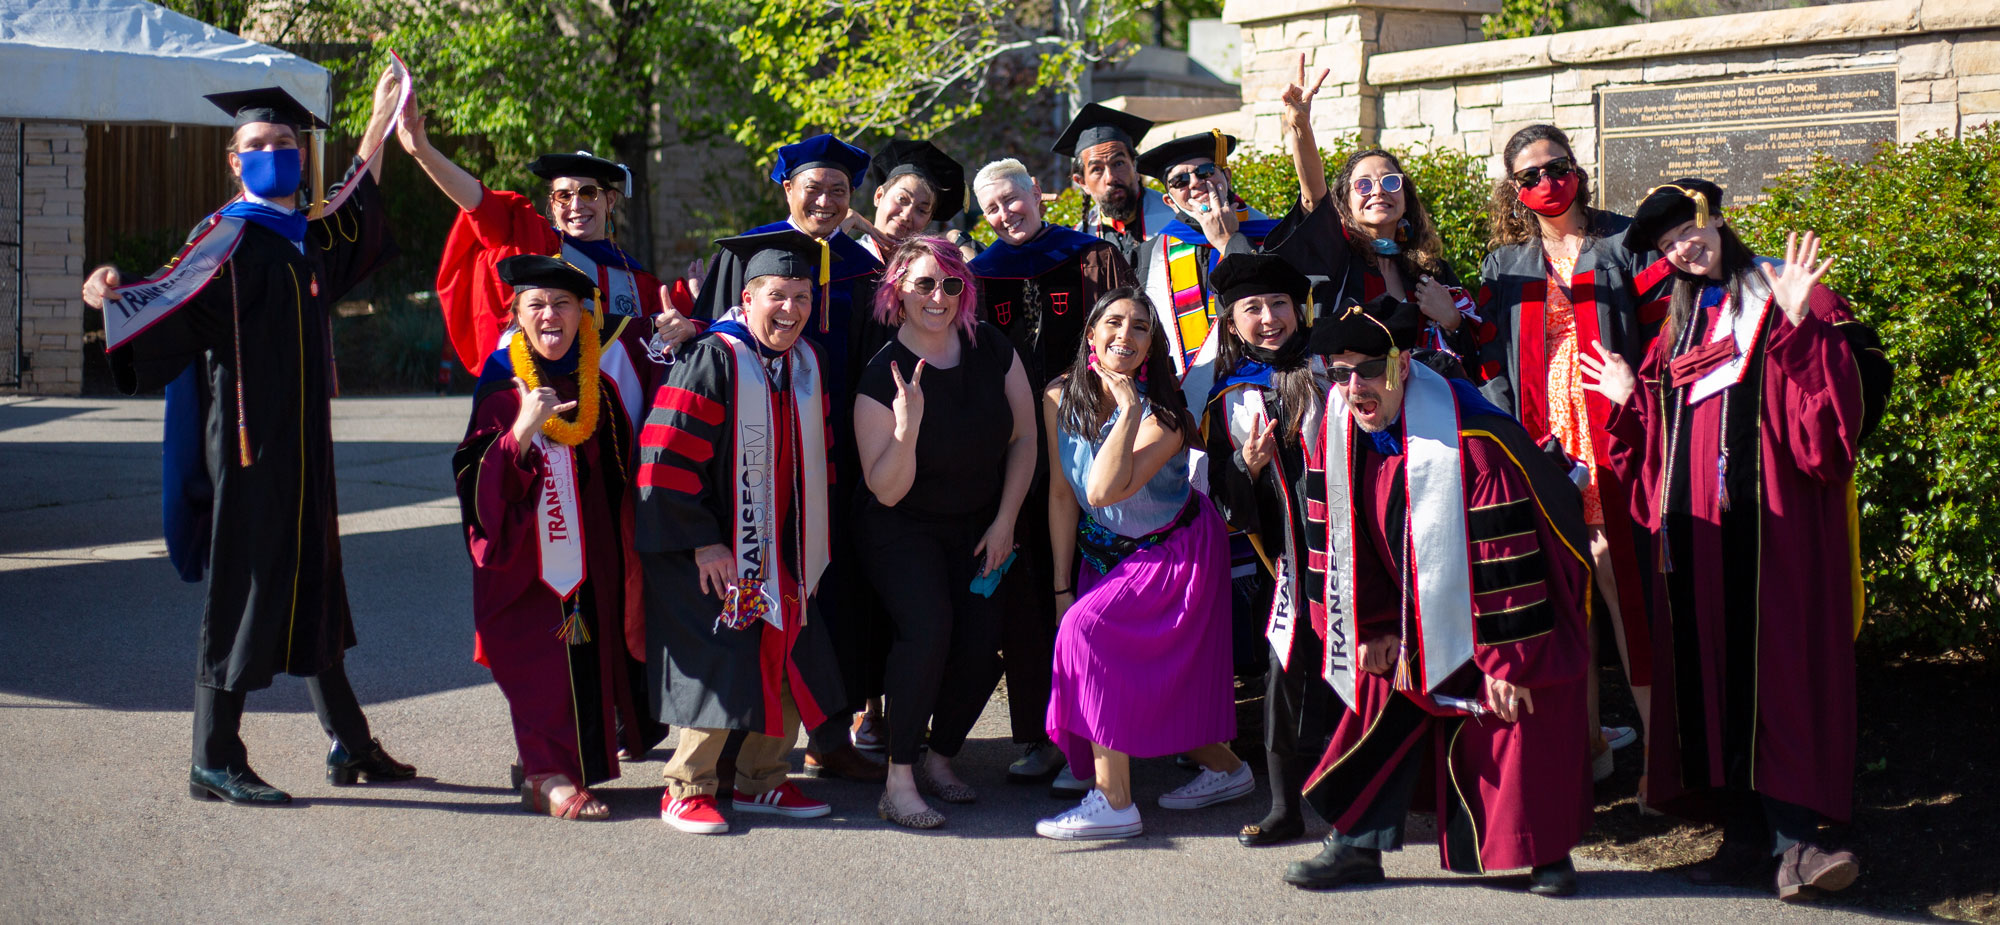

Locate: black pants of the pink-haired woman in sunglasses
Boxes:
[860,507,1008,765]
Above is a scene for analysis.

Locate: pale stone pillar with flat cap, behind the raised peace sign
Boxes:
[1222,0,1500,148]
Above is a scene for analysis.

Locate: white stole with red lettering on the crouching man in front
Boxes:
[1322,362,1472,709]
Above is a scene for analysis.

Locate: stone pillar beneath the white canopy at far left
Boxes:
[18,122,84,394]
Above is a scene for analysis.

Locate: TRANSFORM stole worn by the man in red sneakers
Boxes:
[716,332,832,629]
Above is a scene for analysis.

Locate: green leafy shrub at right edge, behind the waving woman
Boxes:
[1734,124,2000,651]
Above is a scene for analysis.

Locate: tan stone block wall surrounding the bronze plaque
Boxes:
[1224,0,2000,176]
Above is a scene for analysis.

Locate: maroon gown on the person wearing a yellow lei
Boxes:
[452,318,654,785]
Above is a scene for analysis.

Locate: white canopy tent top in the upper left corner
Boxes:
[0,0,332,126]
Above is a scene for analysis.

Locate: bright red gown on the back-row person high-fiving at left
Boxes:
[438,190,676,370]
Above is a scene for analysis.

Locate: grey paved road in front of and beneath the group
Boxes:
[0,396,1896,923]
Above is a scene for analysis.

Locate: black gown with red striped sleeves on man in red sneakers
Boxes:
[636,334,850,735]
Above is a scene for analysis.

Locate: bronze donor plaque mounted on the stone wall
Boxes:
[1598,68,1896,212]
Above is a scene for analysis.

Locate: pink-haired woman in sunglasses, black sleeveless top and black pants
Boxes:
[854,236,1036,829]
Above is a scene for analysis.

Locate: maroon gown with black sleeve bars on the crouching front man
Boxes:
[1306,396,1592,873]
